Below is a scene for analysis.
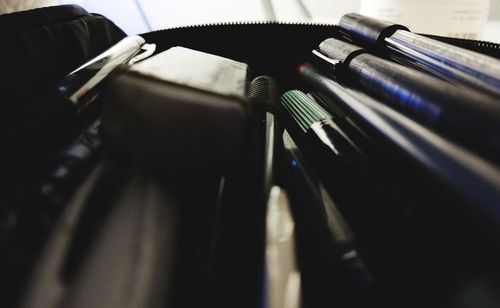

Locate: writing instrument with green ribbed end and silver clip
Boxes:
[281,90,379,229]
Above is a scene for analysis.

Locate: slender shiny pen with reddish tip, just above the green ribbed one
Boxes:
[300,65,500,231]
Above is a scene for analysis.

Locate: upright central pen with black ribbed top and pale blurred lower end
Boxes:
[249,76,302,308]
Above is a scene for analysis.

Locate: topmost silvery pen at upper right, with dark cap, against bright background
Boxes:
[339,13,500,98]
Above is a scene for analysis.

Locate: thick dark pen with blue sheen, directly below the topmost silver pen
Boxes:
[313,39,500,160]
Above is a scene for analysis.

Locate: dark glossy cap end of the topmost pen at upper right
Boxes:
[339,13,410,48]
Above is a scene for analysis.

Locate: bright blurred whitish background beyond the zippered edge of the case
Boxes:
[61,0,500,42]
